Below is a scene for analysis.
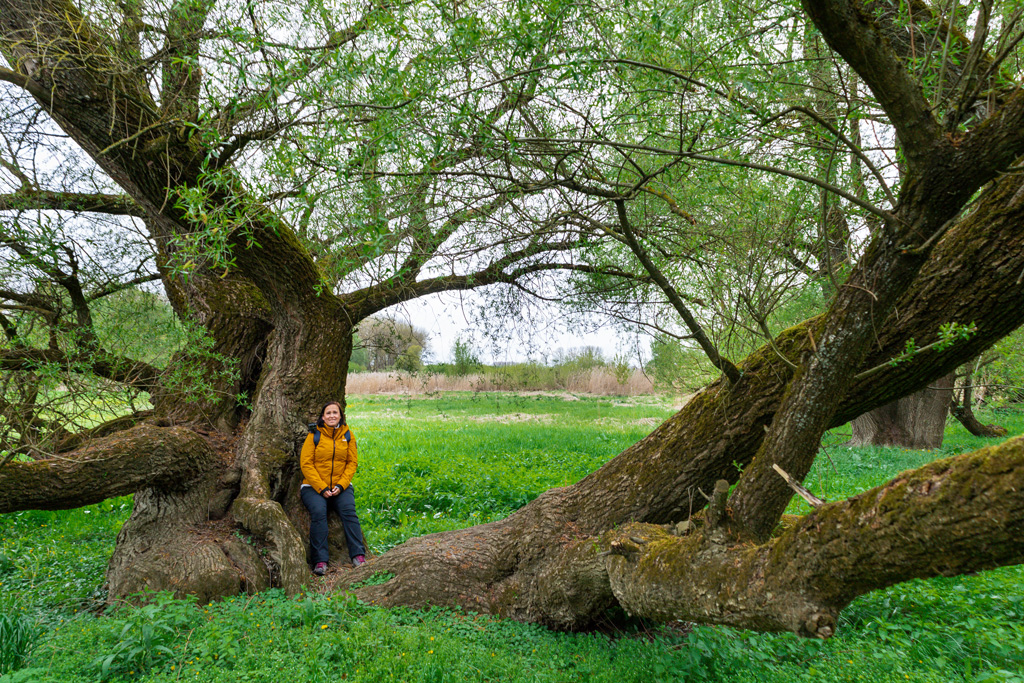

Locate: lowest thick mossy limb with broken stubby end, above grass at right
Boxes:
[601,437,1024,638]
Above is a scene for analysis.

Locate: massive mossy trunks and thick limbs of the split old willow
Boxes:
[0,0,1024,637]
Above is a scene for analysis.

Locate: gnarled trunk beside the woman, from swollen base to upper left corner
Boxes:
[0,0,360,598]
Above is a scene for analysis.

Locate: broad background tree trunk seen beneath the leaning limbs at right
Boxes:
[850,374,955,449]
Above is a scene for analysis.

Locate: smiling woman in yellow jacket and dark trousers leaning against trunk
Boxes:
[299,400,367,577]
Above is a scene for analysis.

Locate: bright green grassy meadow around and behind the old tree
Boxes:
[0,392,1024,683]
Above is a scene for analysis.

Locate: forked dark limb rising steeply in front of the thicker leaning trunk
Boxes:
[730,0,1024,541]
